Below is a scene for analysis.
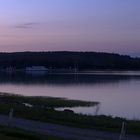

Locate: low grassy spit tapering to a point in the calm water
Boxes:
[0,93,98,108]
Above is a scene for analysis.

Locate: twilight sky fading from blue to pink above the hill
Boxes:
[0,0,140,56]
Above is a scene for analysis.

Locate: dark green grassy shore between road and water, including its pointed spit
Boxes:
[0,94,140,135]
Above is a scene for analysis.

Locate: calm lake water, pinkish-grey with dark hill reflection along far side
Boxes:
[0,72,140,119]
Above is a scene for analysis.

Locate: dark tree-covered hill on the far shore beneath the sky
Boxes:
[0,51,140,70]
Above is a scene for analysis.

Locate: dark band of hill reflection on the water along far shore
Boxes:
[0,73,140,86]
